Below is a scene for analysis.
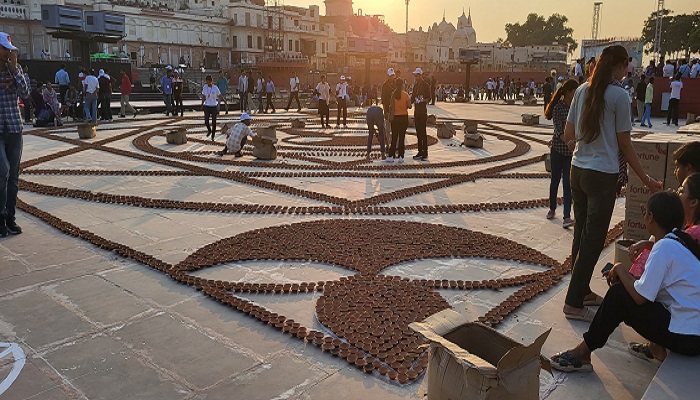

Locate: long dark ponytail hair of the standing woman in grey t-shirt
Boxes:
[580,45,629,143]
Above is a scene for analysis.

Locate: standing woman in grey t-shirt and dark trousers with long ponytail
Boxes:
[563,45,663,322]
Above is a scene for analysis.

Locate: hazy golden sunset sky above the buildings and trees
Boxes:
[285,0,700,42]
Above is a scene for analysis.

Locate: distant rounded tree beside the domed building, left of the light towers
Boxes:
[504,13,578,53]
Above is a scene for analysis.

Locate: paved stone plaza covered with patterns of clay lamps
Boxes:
[0,103,684,400]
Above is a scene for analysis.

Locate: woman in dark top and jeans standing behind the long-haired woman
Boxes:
[544,79,578,228]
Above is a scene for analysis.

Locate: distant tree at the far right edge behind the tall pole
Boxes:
[642,10,700,57]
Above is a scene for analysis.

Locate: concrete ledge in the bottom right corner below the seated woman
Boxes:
[642,353,700,400]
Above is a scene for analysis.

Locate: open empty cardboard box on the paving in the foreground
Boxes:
[409,310,551,400]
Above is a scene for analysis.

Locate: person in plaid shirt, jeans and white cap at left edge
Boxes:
[0,32,29,237]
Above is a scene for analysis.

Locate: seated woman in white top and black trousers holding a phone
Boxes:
[552,192,700,372]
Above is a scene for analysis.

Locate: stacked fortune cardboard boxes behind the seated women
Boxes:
[625,134,700,240]
